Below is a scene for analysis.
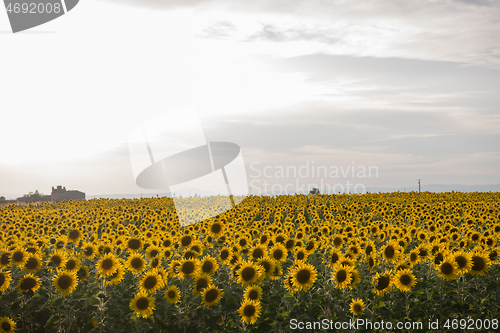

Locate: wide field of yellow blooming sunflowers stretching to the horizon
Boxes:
[0,192,500,333]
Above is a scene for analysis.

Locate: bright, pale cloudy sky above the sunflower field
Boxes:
[0,0,500,198]
